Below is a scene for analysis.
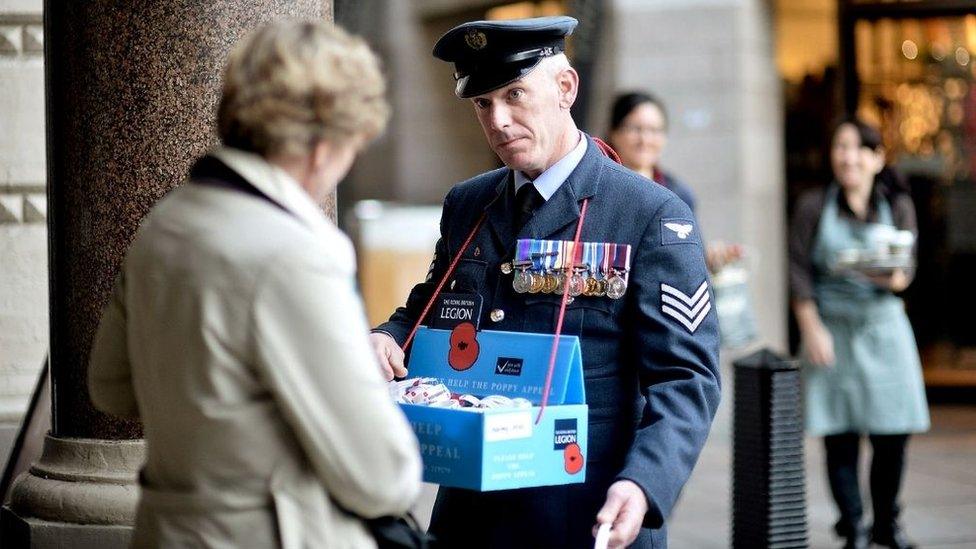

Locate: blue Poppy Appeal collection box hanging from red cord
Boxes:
[401,328,587,491]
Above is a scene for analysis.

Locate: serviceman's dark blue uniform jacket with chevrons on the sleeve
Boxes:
[377,135,719,547]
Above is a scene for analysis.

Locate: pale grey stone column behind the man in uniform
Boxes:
[595,0,787,349]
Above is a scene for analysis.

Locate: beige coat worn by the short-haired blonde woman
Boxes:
[89,149,420,549]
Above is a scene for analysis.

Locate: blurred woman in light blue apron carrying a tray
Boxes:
[790,119,929,548]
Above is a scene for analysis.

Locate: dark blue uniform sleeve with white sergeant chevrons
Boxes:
[617,198,720,528]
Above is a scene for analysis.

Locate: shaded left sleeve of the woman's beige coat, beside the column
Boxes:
[88,274,139,418]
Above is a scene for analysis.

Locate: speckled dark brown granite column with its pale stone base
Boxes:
[0,0,332,547]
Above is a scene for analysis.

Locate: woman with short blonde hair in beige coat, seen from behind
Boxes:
[89,22,420,547]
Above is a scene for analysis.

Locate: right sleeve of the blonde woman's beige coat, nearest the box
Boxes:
[252,250,421,518]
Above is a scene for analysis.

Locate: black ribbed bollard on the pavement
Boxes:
[732,349,808,549]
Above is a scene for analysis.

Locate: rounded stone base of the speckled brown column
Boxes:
[0,434,145,548]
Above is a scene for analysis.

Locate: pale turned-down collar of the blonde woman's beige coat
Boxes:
[210,147,332,228]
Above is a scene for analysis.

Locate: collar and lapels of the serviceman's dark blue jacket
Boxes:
[485,134,604,250]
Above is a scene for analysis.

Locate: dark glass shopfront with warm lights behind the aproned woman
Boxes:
[841,1,976,387]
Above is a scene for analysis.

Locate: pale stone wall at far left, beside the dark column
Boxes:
[0,0,48,458]
